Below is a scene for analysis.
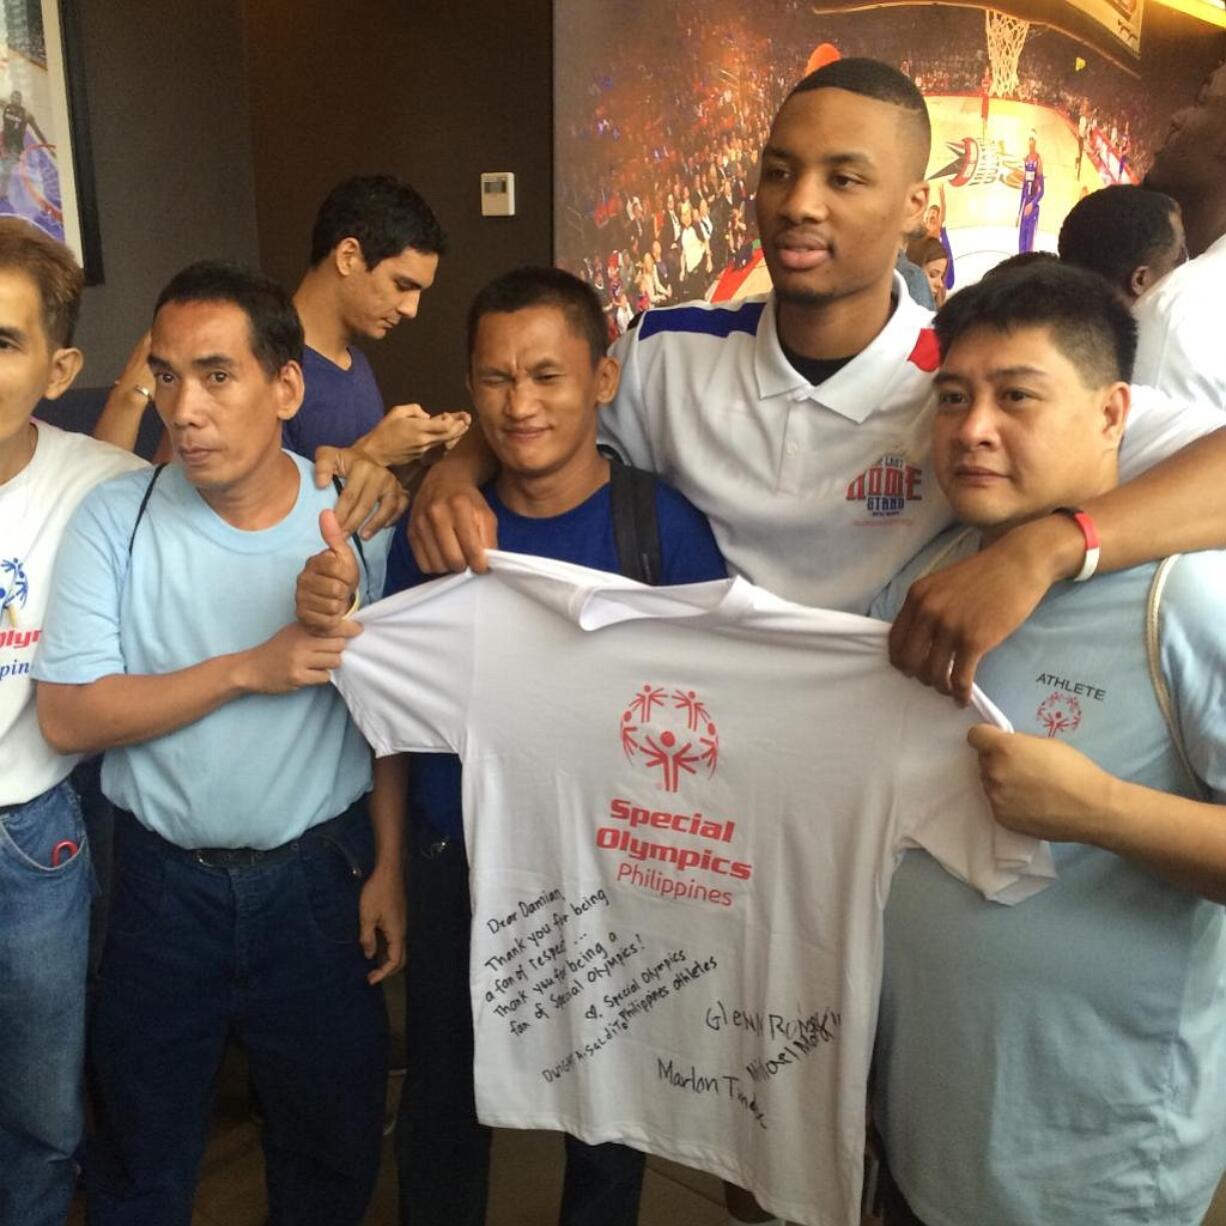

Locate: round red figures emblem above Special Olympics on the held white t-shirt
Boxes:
[619,684,720,792]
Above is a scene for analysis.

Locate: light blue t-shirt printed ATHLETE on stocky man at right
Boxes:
[873,528,1226,1226]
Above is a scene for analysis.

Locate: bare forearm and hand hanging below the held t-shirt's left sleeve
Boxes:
[358,754,408,983]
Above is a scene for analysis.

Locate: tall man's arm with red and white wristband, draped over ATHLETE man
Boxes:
[890,429,1226,704]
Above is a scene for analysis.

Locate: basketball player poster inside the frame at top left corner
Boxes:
[0,0,98,281]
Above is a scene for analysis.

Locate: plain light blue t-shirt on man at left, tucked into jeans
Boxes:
[34,456,390,848]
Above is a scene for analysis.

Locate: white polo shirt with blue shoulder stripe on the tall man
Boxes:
[602,276,1222,613]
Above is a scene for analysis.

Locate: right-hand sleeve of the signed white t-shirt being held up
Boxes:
[895,684,1056,905]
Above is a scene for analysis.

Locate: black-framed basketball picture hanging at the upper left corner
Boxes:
[0,0,102,284]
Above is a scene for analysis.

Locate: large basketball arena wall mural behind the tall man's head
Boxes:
[554,0,1226,336]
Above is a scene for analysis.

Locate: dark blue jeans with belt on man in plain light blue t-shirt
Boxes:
[86,803,387,1226]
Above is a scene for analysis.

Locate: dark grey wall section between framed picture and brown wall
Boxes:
[77,0,257,377]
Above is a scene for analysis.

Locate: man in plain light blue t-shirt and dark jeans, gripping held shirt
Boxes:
[34,262,403,1226]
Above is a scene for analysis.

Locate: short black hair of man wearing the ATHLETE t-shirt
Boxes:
[933,260,1137,387]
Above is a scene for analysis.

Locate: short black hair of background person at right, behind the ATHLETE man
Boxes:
[1059,183,1177,293]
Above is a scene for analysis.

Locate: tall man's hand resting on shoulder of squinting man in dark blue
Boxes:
[408,407,498,575]
